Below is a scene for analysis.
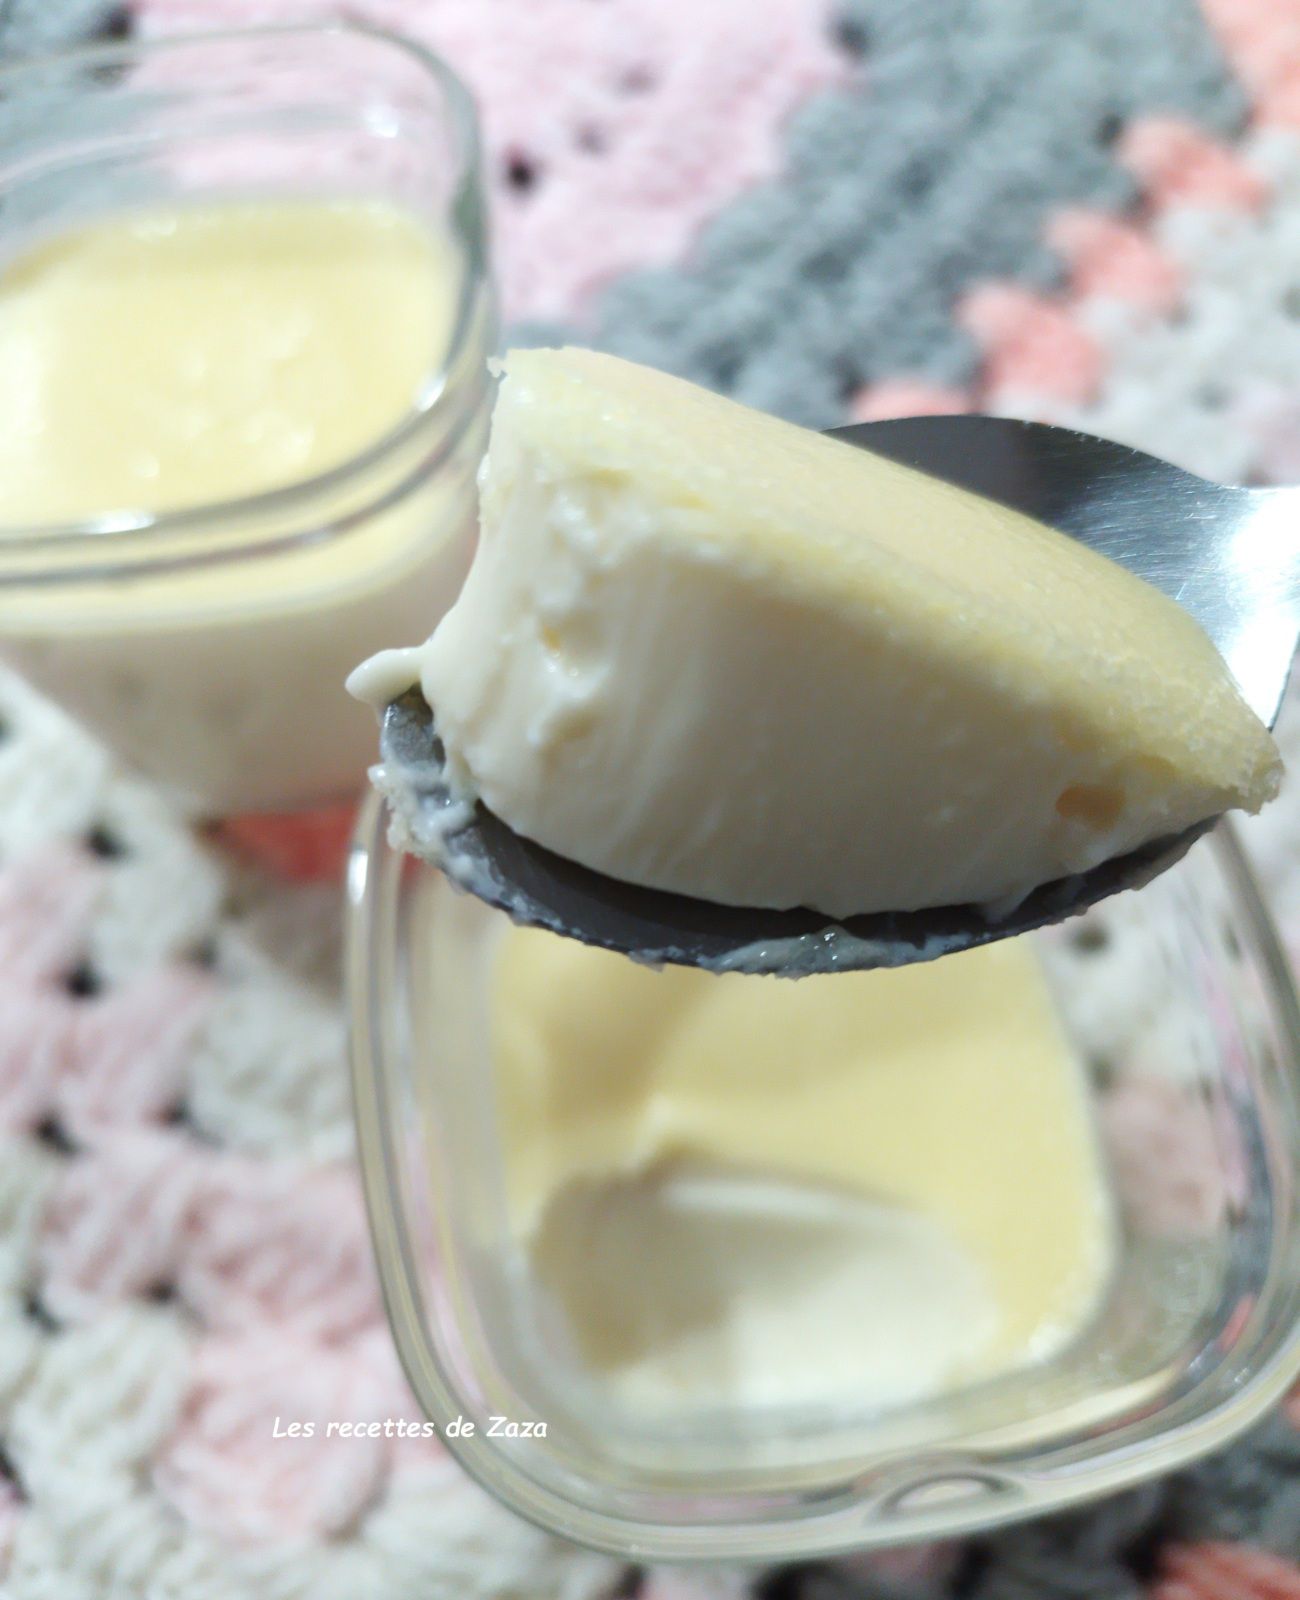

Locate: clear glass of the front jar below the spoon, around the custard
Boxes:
[347,797,1300,1562]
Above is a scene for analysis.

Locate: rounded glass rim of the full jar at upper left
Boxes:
[0,19,483,563]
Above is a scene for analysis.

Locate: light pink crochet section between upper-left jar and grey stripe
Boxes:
[139,0,844,318]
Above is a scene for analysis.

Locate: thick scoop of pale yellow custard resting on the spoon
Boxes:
[351,349,1281,917]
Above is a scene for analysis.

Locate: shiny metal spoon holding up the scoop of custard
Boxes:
[376,416,1300,976]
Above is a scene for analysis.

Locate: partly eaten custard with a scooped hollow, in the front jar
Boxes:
[492,928,1111,1410]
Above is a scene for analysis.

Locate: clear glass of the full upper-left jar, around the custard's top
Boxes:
[0,24,495,816]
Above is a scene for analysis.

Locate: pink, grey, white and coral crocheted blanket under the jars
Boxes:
[0,0,1300,1600]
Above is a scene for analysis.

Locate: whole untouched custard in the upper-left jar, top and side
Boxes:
[0,198,487,810]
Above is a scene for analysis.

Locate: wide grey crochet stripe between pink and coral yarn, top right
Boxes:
[579,0,1244,427]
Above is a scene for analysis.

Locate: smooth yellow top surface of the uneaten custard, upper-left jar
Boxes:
[0,198,459,530]
